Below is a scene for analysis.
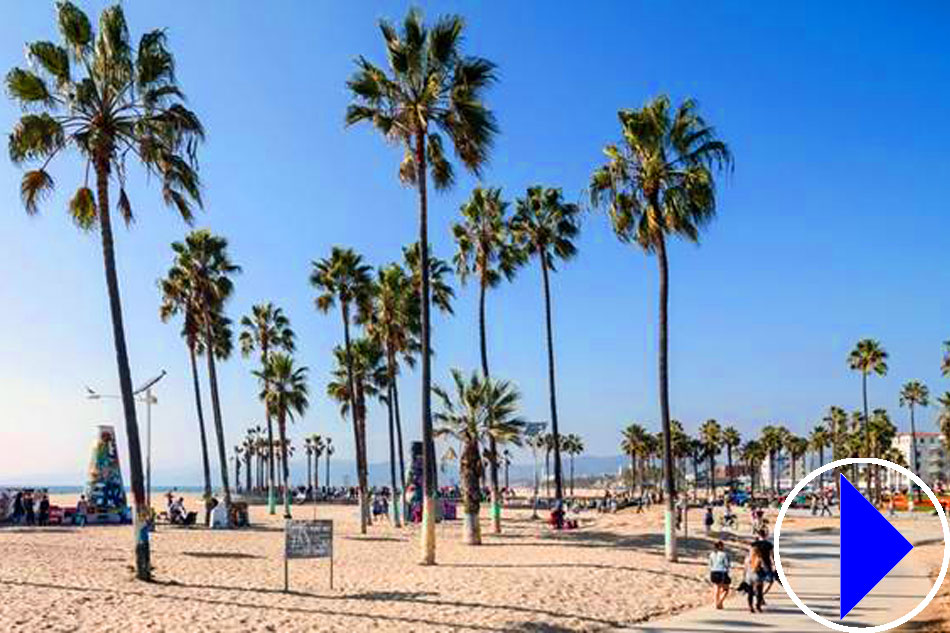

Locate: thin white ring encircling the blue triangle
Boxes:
[775,457,950,633]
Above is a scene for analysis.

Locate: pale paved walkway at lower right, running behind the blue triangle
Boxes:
[626,524,932,633]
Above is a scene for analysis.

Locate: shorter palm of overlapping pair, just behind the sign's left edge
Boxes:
[254,352,309,519]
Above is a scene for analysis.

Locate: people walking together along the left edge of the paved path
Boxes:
[709,529,778,613]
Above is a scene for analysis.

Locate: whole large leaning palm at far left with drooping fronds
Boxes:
[6,2,205,580]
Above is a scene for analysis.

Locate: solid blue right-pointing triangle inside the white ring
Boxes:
[839,475,914,620]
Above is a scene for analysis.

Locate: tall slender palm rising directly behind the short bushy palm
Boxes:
[452,187,521,534]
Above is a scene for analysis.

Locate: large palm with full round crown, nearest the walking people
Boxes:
[590,95,732,561]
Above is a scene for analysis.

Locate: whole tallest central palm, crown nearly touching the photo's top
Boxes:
[346,9,497,565]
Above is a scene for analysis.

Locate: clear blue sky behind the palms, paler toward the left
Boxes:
[0,0,950,483]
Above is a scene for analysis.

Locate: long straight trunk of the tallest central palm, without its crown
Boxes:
[414,130,438,565]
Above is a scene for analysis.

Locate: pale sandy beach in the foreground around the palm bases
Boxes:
[0,499,752,631]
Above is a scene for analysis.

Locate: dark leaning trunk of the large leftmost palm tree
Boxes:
[96,160,152,580]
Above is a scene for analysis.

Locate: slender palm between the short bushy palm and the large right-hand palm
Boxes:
[509,187,580,528]
